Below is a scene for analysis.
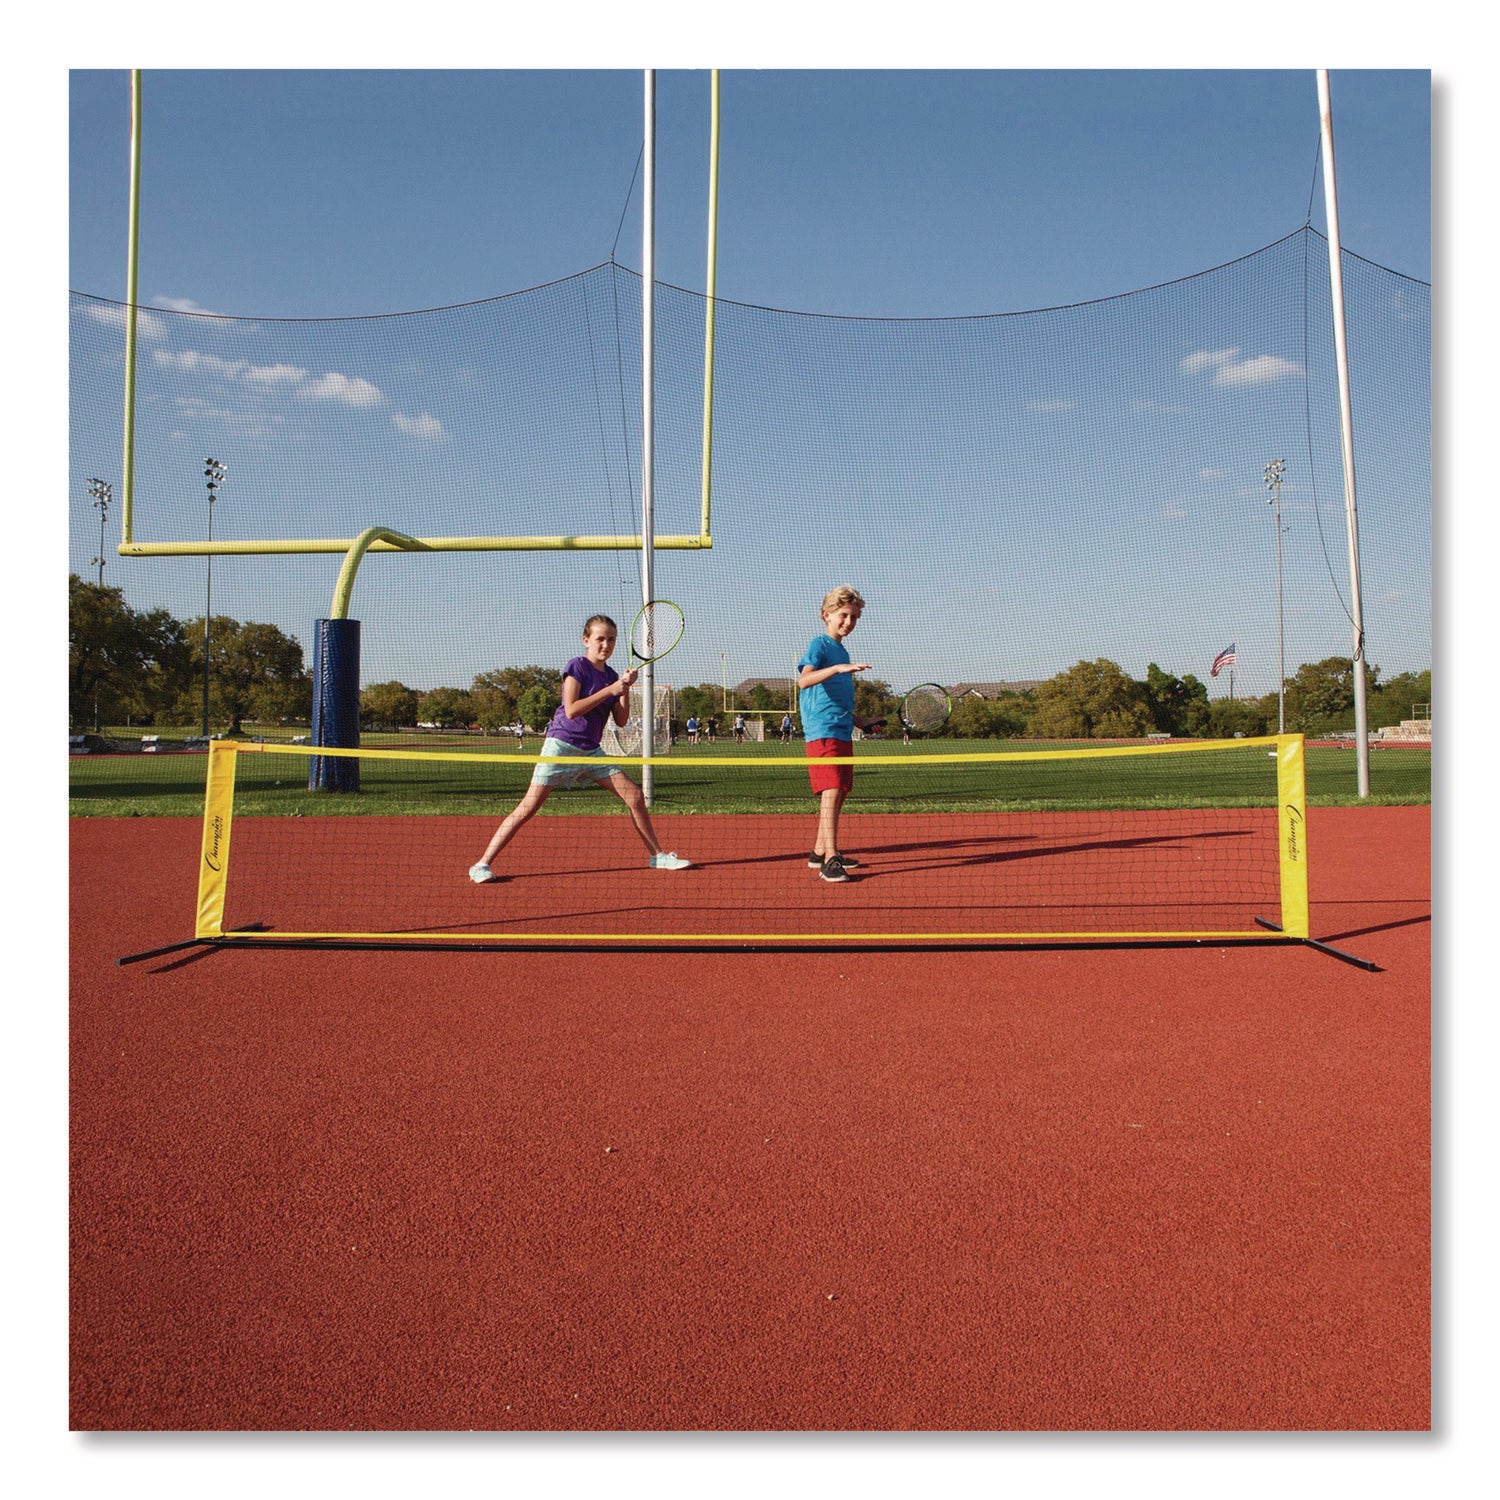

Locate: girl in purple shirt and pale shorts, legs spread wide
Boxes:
[470,615,692,885]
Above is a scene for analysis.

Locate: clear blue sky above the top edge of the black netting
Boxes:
[69,69,1431,317]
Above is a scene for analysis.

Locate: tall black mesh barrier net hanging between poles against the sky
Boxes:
[71,228,1431,707]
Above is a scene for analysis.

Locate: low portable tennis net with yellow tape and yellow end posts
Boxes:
[122,735,1358,962]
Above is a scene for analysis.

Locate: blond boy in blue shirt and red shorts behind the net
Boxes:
[797,585,870,882]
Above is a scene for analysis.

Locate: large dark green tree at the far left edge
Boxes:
[68,573,192,726]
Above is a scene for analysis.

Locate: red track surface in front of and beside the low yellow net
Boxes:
[71,809,1431,1430]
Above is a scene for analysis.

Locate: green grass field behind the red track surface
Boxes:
[68,732,1433,818]
